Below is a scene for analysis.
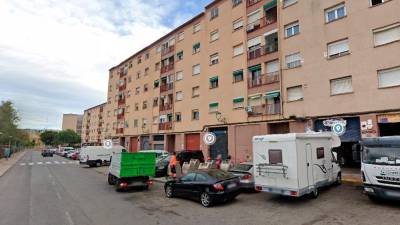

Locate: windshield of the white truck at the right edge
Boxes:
[363,147,400,166]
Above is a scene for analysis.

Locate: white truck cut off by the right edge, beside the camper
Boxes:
[361,136,400,200]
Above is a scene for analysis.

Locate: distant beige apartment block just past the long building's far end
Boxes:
[81,103,107,145]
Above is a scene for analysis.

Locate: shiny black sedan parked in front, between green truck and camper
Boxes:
[164,169,240,207]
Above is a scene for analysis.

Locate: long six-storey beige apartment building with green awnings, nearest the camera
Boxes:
[101,0,400,165]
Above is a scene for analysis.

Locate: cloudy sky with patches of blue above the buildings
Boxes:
[0,0,212,129]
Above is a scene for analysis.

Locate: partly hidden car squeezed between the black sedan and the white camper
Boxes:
[229,162,255,190]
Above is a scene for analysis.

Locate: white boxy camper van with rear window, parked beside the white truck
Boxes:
[253,133,341,197]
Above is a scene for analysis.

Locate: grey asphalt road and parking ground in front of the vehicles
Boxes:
[0,149,400,225]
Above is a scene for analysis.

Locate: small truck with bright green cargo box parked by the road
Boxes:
[108,152,156,191]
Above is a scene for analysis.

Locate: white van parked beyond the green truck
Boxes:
[79,145,126,167]
